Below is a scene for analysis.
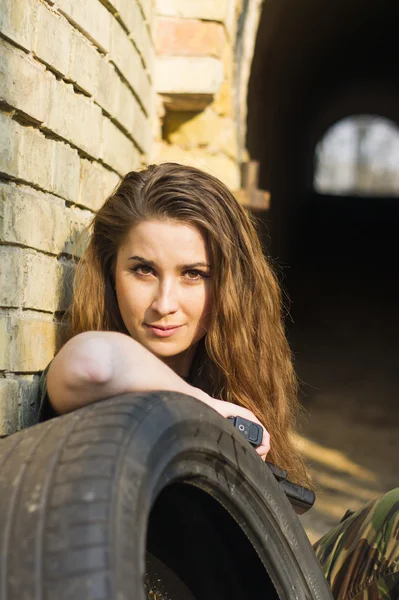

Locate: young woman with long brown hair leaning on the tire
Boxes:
[40,163,399,600]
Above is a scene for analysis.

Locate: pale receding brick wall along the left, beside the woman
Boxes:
[0,0,154,435]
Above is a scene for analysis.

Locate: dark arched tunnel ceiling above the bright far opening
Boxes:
[247,0,399,255]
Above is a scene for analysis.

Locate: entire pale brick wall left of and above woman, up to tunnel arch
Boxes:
[0,0,262,436]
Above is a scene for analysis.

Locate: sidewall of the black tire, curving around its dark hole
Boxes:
[108,392,332,600]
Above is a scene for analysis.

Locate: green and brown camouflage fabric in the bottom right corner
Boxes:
[314,488,399,600]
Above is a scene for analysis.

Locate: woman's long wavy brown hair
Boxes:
[70,163,309,483]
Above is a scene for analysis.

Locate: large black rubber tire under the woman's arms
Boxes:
[0,392,332,600]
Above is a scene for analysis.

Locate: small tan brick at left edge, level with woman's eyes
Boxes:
[0,246,24,307]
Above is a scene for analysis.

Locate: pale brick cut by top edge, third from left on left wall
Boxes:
[58,0,113,52]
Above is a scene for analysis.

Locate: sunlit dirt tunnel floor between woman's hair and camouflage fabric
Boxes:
[301,390,399,542]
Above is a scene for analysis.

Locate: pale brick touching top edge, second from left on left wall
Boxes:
[32,3,71,76]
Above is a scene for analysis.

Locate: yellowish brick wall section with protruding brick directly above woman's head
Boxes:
[154,0,244,190]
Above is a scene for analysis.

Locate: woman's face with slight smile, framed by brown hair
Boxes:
[115,220,210,377]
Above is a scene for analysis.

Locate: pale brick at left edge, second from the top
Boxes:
[0,39,51,123]
